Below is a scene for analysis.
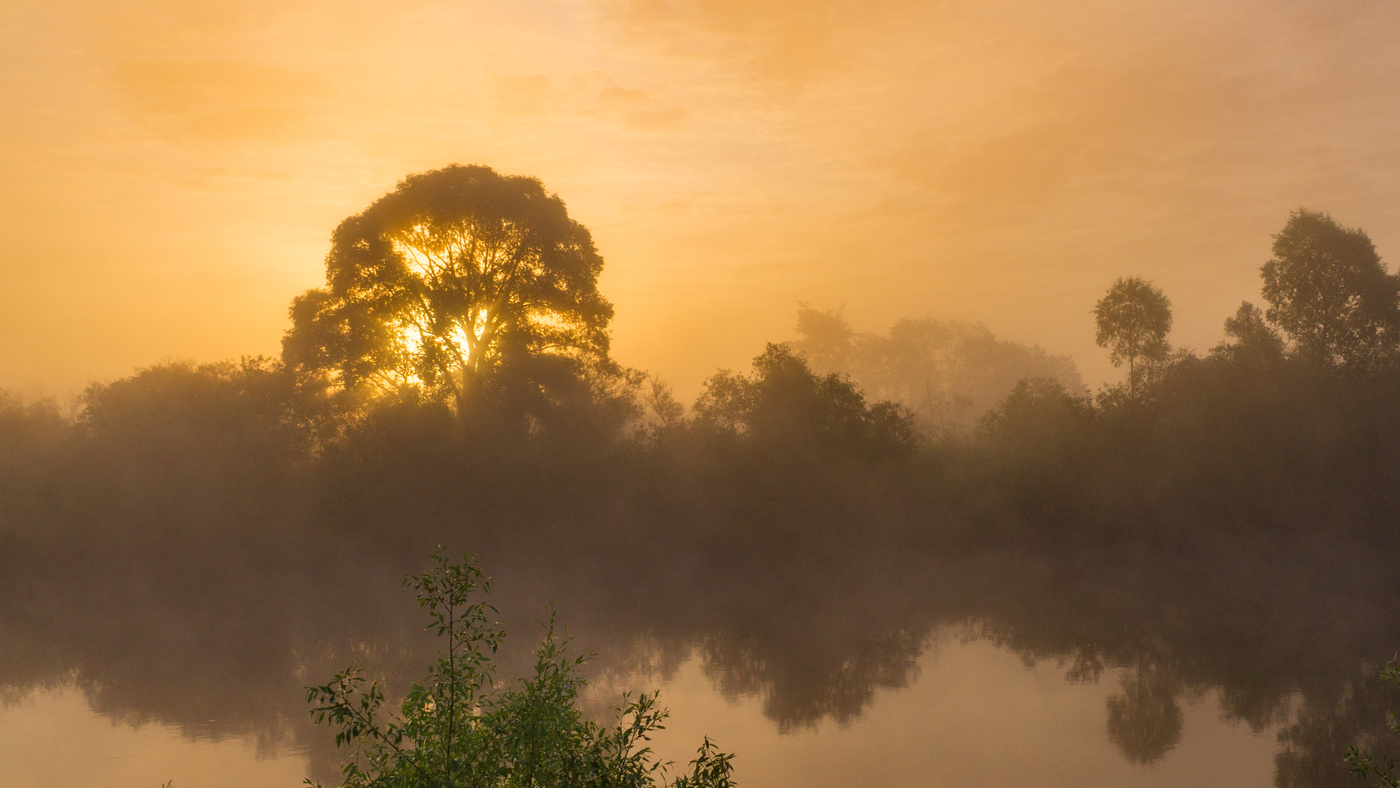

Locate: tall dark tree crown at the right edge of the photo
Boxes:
[1261,210,1400,367]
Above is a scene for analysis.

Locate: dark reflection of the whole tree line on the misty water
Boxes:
[0,515,1400,787]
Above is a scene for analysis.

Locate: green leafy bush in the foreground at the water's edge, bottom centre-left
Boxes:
[307,550,734,788]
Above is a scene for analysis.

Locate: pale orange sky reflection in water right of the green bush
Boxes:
[632,641,1277,788]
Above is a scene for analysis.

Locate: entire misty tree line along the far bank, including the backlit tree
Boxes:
[0,165,1400,565]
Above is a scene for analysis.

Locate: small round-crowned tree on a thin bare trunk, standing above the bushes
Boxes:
[1093,276,1172,399]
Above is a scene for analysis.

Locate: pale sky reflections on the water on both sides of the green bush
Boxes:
[0,640,1282,788]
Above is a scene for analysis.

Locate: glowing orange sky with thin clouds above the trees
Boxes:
[0,0,1400,397]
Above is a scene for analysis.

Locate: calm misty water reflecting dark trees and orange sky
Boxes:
[0,534,1400,788]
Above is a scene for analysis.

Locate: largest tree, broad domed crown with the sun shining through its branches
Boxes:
[283,165,613,409]
